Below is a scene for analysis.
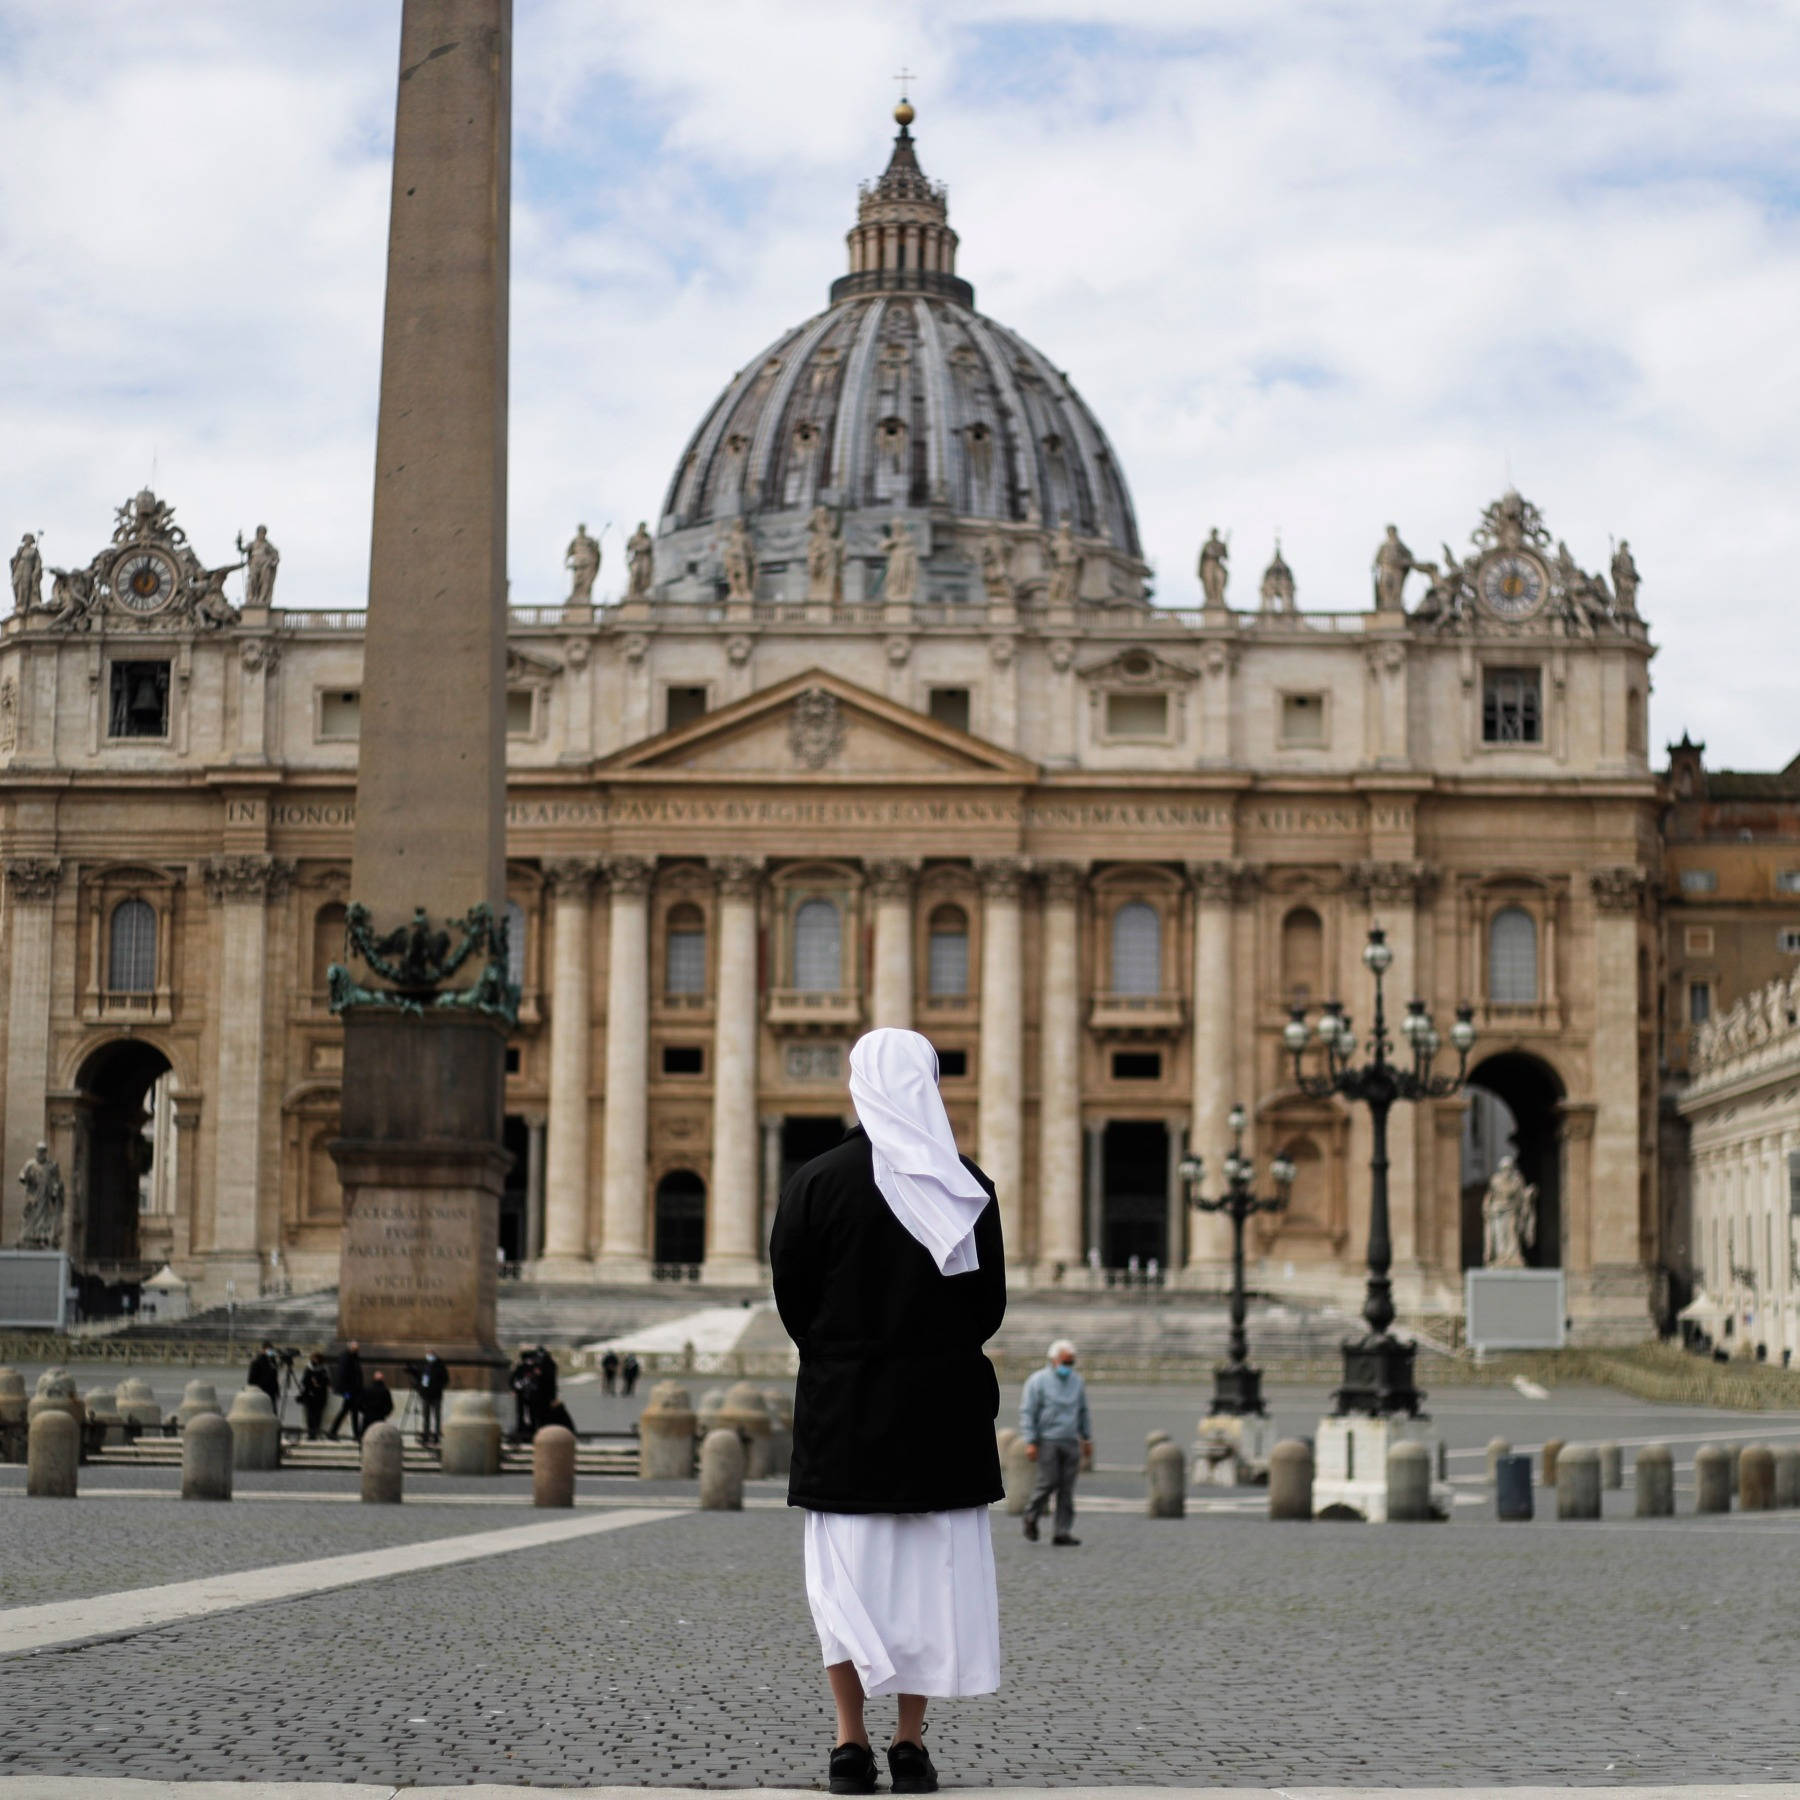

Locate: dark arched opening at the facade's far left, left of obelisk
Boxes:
[72,1039,169,1280]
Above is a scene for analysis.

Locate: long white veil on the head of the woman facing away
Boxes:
[850,1026,988,1274]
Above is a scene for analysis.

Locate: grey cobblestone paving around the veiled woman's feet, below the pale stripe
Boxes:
[0,1503,1800,1787]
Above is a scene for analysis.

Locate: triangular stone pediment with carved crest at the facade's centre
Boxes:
[596,670,1037,781]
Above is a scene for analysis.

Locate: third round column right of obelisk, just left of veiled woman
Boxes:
[700,857,763,1287]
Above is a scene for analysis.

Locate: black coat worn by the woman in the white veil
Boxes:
[769,1127,1006,1512]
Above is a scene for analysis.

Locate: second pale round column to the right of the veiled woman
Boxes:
[1037,862,1082,1282]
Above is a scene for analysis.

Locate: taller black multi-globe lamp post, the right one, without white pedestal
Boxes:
[1282,925,1474,1418]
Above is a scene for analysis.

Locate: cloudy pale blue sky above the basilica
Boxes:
[0,0,1800,769]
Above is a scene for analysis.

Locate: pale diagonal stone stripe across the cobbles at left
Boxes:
[0,1507,682,1656]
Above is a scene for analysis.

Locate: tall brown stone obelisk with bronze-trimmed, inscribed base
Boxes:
[331,0,518,1386]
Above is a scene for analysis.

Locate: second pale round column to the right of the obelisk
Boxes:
[598,857,650,1282]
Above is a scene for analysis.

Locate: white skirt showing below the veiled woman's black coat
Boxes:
[806,1507,1001,1697]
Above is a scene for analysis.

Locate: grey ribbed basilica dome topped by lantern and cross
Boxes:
[655,103,1148,601]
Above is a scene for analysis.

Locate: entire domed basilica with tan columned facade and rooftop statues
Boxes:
[0,110,1663,1337]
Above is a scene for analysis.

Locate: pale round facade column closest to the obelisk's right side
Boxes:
[535,857,610,1282]
